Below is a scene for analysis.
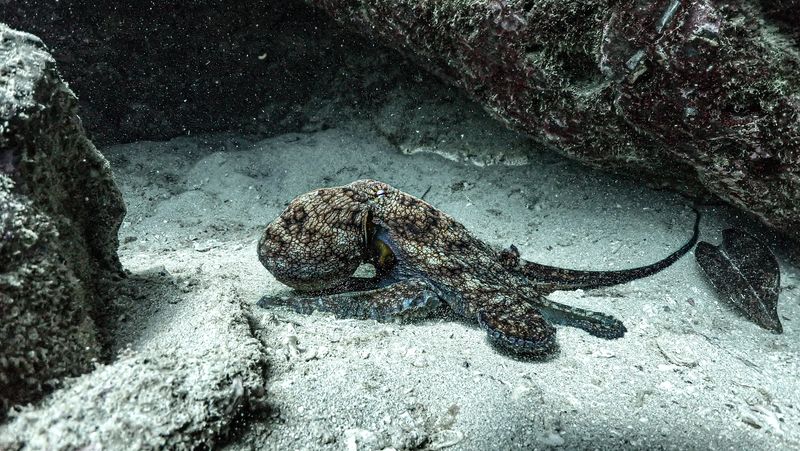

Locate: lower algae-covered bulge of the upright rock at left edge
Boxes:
[0,175,101,413]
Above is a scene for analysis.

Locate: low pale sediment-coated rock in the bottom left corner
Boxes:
[0,290,266,450]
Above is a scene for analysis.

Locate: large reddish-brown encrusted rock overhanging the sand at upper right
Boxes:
[311,0,800,244]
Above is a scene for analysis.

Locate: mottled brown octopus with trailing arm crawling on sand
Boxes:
[258,180,700,356]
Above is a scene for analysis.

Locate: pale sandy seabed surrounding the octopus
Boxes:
[104,117,800,450]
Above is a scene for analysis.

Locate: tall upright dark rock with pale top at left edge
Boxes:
[0,24,125,416]
